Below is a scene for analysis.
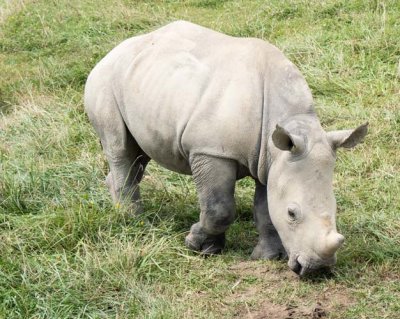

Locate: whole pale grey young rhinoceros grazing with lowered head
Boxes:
[84,21,368,275]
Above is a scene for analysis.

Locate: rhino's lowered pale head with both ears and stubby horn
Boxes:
[268,116,368,275]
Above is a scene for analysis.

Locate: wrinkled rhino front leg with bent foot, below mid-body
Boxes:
[185,155,237,254]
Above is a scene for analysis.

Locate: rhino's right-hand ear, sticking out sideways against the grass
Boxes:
[327,122,368,150]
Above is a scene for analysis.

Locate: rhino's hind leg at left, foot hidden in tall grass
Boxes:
[85,86,150,213]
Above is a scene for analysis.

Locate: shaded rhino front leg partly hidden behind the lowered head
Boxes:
[251,180,286,259]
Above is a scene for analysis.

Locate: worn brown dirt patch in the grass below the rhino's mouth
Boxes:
[225,261,354,319]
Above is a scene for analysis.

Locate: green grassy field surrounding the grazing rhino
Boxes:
[0,0,400,319]
